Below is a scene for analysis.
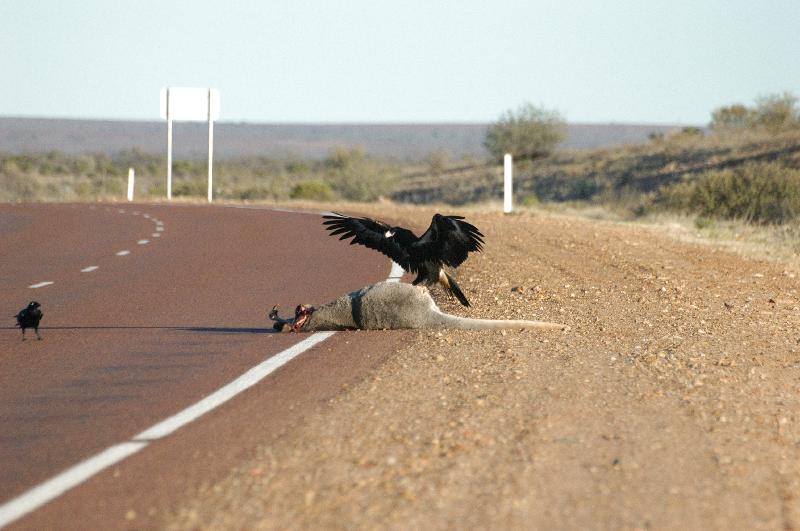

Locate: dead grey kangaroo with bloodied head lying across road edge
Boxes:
[269,282,569,332]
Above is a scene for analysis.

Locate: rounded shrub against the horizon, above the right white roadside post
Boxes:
[483,103,566,160]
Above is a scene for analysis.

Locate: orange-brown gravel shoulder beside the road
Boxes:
[164,207,800,529]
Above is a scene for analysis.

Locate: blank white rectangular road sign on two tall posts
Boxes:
[161,87,219,203]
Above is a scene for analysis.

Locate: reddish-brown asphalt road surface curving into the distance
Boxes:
[0,204,402,529]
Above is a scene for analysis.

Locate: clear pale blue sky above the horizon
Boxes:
[0,0,800,124]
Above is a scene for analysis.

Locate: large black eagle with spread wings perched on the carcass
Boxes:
[322,212,483,306]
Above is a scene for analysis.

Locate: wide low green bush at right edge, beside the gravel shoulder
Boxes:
[661,162,800,224]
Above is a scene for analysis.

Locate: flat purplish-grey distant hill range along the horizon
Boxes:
[0,117,680,160]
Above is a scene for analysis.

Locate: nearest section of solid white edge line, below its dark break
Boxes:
[0,441,147,527]
